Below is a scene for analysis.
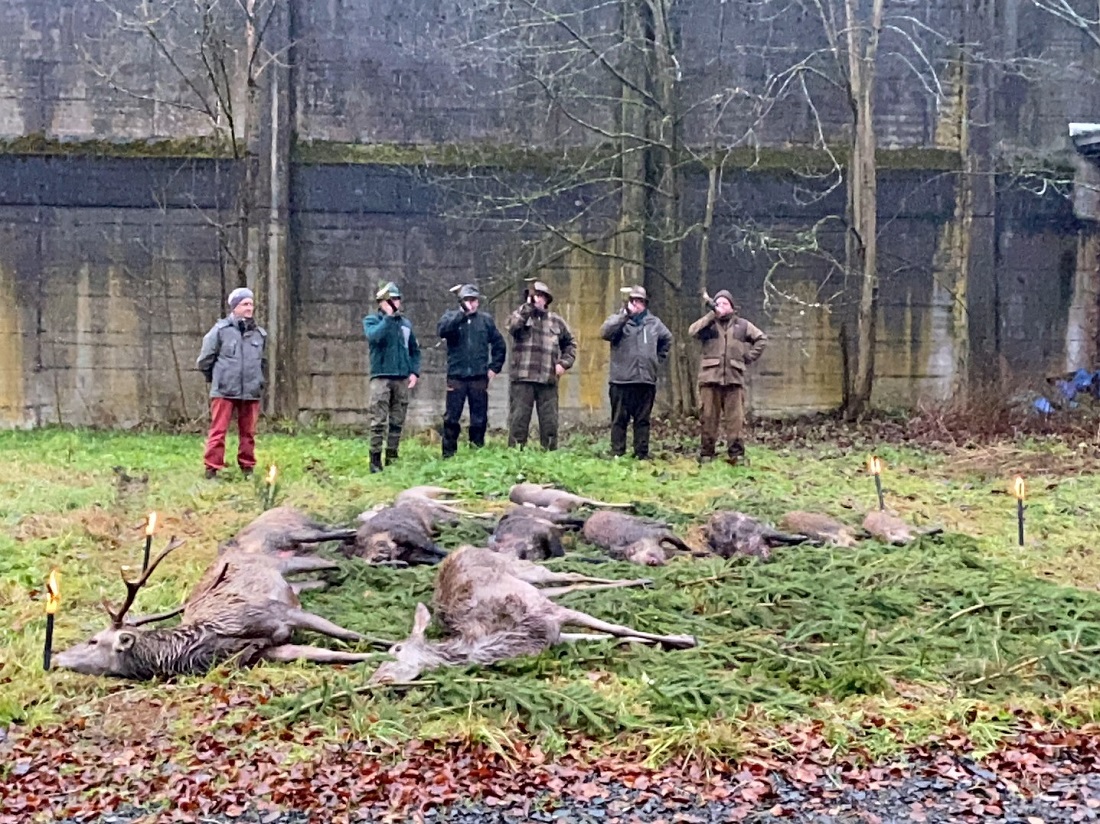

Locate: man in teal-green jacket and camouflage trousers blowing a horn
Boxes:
[363,281,420,472]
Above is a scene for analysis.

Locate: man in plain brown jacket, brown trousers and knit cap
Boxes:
[688,289,768,463]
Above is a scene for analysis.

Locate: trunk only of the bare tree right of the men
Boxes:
[845,0,883,419]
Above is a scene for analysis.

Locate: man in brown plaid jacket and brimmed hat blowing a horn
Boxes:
[508,281,576,450]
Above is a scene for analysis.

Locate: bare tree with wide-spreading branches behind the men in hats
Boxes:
[418,0,756,413]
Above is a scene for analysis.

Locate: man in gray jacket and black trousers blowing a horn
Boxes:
[600,286,672,461]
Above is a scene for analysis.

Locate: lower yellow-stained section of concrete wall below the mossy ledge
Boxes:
[0,157,1088,426]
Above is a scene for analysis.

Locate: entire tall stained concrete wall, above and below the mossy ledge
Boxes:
[0,0,1100,426]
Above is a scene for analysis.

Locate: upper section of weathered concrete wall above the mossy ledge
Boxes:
[0,0,1100,155]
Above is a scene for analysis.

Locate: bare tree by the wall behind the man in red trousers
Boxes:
[84,0,296,411]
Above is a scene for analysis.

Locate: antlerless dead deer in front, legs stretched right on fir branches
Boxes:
[371,547,695,683]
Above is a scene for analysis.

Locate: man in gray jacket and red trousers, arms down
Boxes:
[196,287,267,477]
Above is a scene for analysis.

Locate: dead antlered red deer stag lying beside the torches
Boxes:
[54,530,384,679]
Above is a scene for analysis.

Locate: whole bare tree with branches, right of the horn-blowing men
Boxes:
[743,0,950,418]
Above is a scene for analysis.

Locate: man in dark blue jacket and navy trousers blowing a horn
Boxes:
[437,284,506,458]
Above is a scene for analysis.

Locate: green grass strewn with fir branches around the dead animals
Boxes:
[0,430,1100,760]
